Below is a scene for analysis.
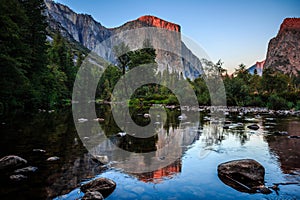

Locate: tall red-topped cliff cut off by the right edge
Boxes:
[264,18,300,75]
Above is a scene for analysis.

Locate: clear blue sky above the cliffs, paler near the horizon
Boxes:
[57,0,300,72]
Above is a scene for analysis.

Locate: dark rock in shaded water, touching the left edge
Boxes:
[0,155,27,170]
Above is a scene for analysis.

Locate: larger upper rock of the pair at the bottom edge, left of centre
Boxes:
[80,178,116,198]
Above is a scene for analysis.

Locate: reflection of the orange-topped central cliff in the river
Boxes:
[90,107,229,183]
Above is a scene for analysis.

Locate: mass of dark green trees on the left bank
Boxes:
[0,0,82,110]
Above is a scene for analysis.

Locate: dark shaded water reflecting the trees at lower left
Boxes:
[0,112,103,199]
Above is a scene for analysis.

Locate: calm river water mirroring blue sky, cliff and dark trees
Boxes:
[0,107,300,199]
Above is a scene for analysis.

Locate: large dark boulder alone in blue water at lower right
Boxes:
[218,159,265,193]
